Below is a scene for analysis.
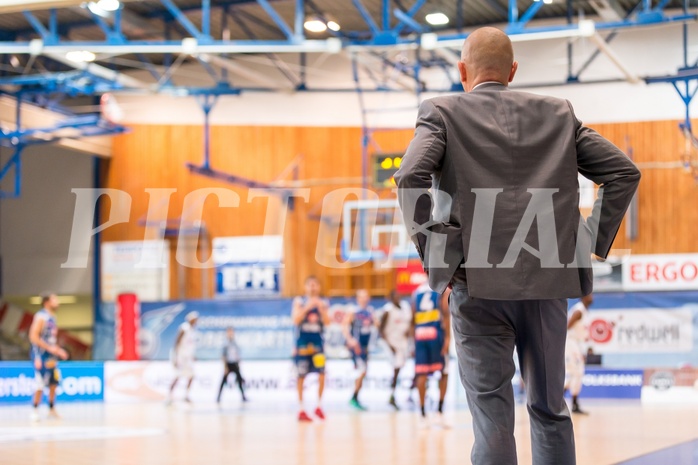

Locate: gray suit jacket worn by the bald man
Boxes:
[395,83,640,300]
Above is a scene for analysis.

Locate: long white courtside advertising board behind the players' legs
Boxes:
[105,359,462,408]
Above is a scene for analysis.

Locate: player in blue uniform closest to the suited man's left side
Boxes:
[412,283,451,423]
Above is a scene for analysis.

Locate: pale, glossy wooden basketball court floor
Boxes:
[0,401,698,465]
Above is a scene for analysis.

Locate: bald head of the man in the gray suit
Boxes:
[458,27,517,92]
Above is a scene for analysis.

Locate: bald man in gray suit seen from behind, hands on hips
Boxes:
[395,28,640,465]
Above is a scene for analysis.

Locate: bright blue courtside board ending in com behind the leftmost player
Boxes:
[0,362,104,404]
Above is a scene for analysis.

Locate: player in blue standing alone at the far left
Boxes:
[29,294,68,421]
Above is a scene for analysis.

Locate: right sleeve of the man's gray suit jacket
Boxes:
[567,102,640,258]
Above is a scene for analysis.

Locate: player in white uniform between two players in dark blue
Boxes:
[378,291,412,410]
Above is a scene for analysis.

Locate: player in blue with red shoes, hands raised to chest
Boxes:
[291,276,330,422]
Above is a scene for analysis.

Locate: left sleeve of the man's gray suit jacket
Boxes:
[395,100,446,261]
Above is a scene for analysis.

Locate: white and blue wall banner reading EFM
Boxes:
[212,236,283,297]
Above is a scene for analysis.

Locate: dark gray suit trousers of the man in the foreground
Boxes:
[449,283,576,465]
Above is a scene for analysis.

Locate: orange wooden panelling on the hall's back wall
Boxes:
[103,117,698,298]
